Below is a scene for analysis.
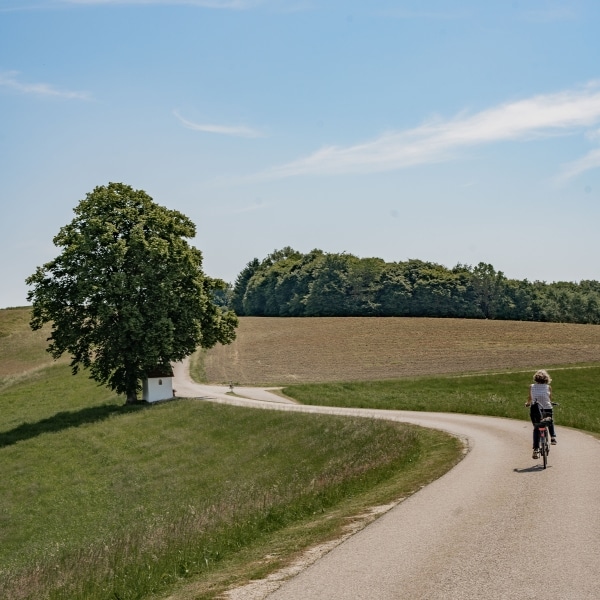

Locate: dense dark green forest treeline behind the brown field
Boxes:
[220,247,600,323]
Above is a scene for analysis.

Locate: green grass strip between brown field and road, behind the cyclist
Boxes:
[284,364,600,433]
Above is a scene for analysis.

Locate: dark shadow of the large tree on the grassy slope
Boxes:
[0,404,145,448]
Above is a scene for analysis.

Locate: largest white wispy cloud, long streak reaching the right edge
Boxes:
[258,85,600,179]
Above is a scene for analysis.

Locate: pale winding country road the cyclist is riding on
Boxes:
[175,365,600,600]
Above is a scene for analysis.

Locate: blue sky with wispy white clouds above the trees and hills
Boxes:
[0,0,600,308]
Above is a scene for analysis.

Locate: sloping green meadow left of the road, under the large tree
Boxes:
[0,310,461,600]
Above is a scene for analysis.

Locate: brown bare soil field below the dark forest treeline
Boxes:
[204,317,600,385]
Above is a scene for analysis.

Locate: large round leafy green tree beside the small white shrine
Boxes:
[27,183,238,403]
